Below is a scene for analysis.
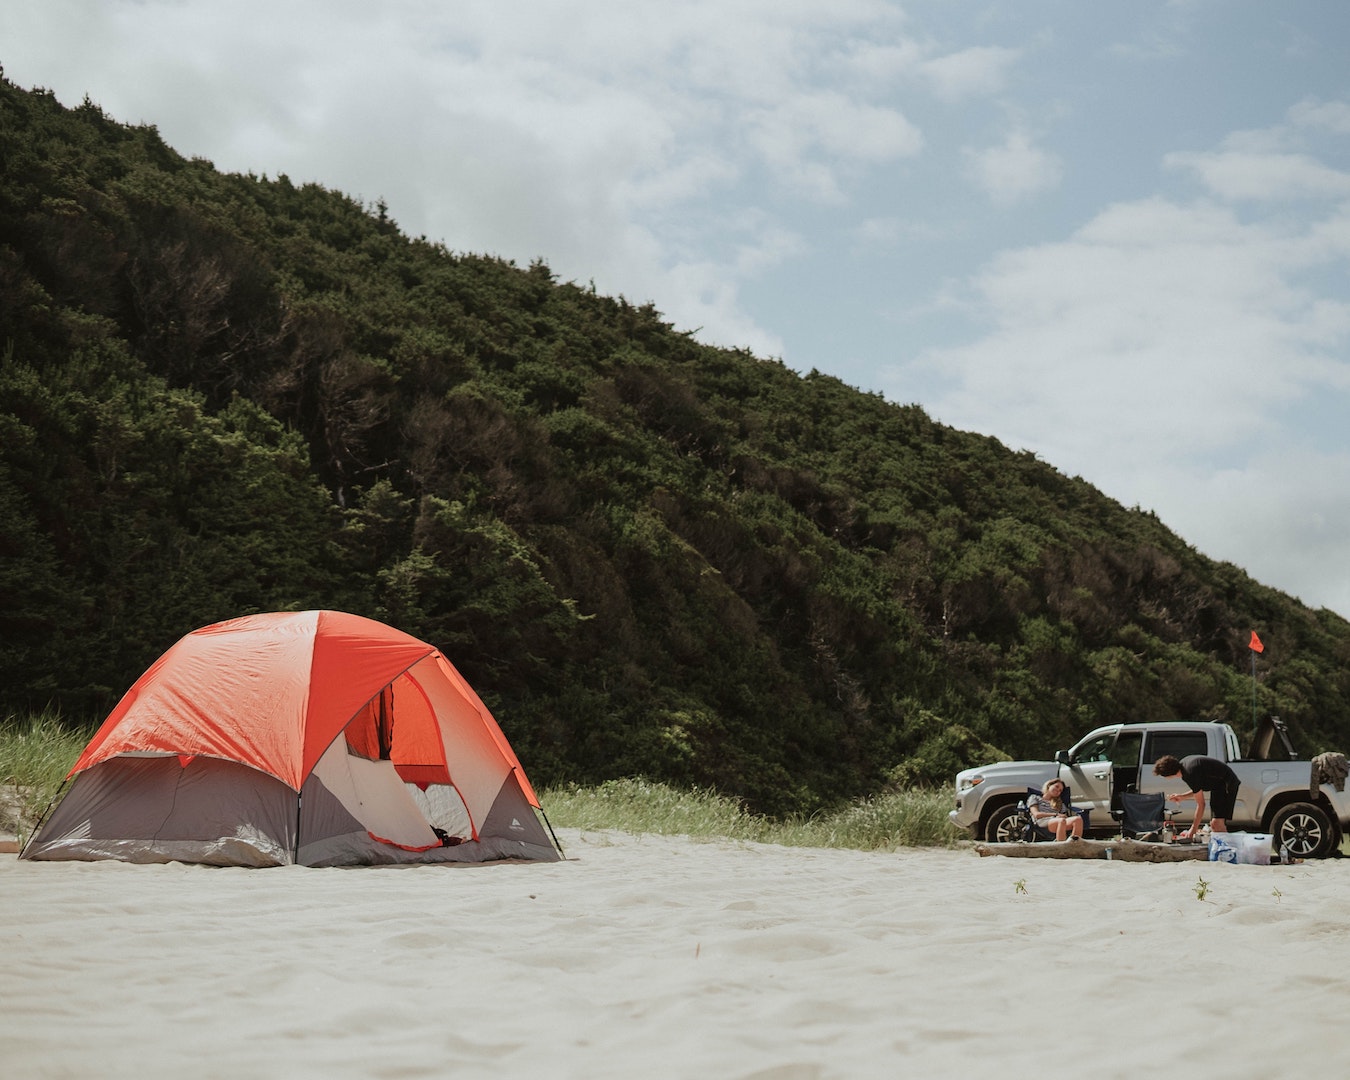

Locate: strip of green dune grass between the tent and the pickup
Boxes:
[540,780,965,851]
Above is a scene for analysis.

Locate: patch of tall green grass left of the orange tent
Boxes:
[0,713,93,840]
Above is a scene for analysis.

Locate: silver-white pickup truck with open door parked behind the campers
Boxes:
[948,717,1350,859]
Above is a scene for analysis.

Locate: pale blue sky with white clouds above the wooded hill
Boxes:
[0,0,1350,629]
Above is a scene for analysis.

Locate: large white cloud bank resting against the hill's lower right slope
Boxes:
[906,190,1350,612]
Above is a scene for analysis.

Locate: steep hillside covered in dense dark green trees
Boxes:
[0,81,1350,813]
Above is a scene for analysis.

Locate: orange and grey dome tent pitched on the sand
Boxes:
[20,612,559,867]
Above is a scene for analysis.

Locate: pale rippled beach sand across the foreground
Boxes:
[0,830,1350,1080]
